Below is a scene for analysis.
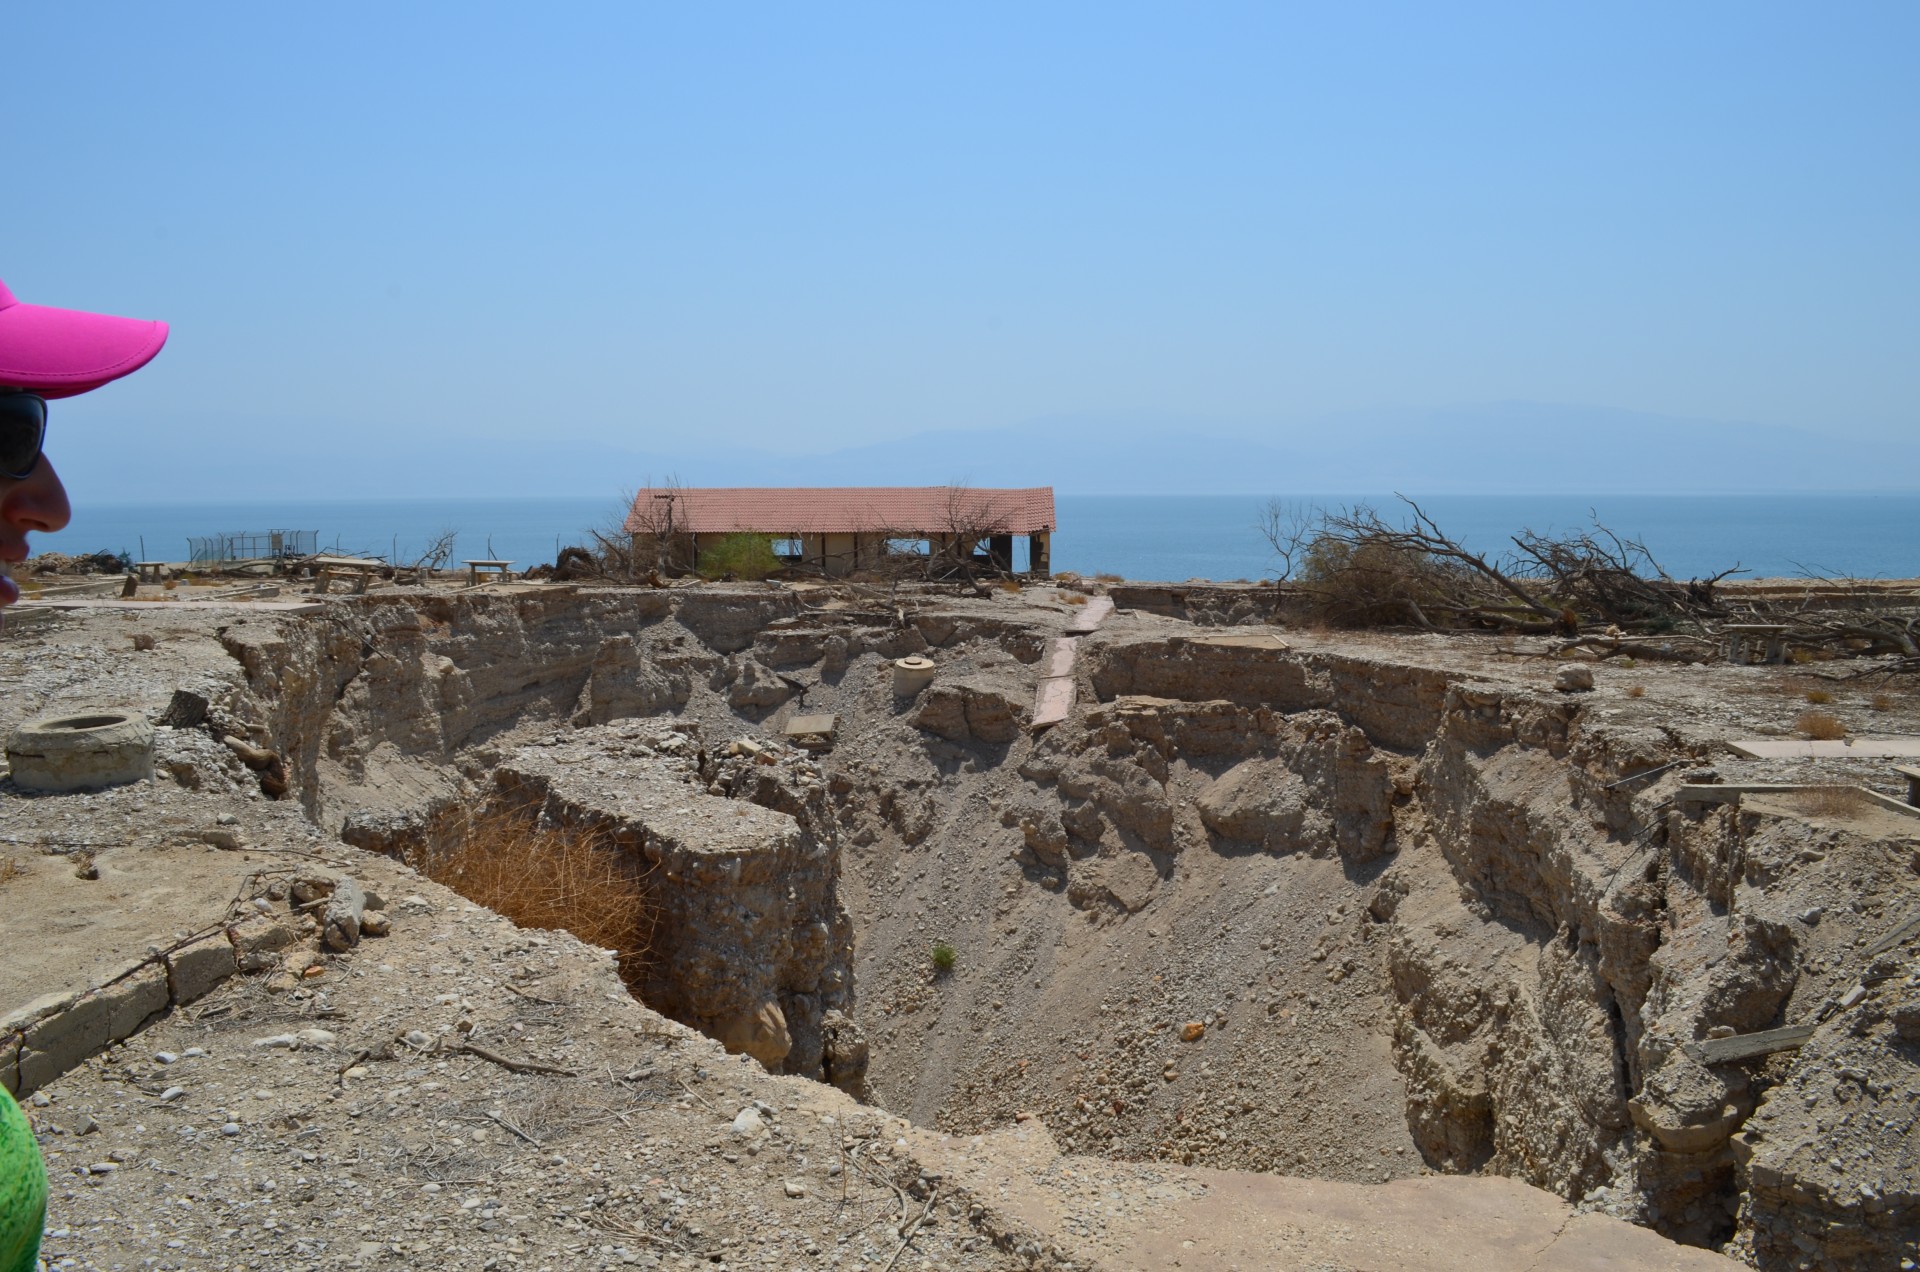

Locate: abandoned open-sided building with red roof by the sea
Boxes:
[626,486,1054,578]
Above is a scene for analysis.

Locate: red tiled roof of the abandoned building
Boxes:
[626,486,1054,536]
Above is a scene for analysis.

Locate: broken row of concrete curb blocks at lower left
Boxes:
[0,922,238,1095]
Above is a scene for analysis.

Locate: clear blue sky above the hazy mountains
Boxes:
[0,2,1920,484]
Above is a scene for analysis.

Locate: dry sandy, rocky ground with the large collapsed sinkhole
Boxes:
[0,586,1920,1268]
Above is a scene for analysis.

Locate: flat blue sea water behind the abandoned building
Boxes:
[45,494,1920,580]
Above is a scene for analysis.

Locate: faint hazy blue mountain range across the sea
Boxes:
[67,404,1920,501]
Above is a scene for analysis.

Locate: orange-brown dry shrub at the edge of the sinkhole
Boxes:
[413,809,655,986]
